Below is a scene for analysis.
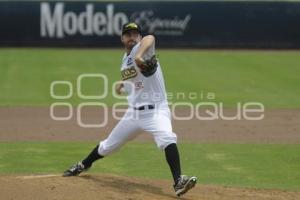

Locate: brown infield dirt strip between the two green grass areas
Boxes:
[0,107,300,144]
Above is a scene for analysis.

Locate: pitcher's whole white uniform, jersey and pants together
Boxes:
[98,40,177,156]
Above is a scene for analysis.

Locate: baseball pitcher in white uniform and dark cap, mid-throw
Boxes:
[63,22,197,196]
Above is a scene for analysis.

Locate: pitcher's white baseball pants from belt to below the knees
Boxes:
[98,104,177,156]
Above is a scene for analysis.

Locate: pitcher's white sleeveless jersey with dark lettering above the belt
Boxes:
[121,43,167,107]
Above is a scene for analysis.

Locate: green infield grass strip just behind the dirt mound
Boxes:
[0,142,300,190]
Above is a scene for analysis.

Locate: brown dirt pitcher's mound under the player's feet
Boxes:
[0,174,300,200]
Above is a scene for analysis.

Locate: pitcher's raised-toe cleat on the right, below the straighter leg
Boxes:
[174,175,197,197]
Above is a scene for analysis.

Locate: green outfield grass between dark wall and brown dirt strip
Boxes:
[0,49,300,108]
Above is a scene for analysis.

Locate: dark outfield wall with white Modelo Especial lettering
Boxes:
[0,1,300,48]
